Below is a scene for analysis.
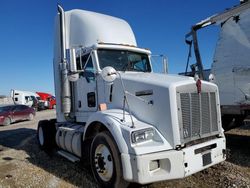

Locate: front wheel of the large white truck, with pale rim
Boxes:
[90,131,128,188]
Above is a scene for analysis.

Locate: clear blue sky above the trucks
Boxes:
[0,0,239,95]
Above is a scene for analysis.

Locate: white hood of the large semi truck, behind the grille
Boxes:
[109,72,196,149]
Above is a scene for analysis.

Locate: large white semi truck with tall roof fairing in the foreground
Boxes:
[37,6,226,187]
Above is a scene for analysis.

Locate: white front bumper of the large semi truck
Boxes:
[121,138,226,184]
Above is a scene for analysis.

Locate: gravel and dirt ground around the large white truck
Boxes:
[0,110,250,188]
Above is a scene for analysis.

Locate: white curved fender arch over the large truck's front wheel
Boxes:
[83,109,136,153]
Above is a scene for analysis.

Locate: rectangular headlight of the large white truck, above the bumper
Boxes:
[131,128,155,143]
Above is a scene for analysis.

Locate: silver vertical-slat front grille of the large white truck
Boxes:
[177,92,218,143]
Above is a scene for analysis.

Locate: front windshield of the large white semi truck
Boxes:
[97,49,151,72]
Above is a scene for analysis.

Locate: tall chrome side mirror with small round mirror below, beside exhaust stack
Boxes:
[66,48,79,82]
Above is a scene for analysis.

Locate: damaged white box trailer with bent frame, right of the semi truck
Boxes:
[182,1,250,130]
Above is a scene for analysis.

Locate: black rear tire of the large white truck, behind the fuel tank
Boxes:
[37,120,56,151]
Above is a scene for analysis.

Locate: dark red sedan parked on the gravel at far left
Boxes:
[0,105,36,125]
